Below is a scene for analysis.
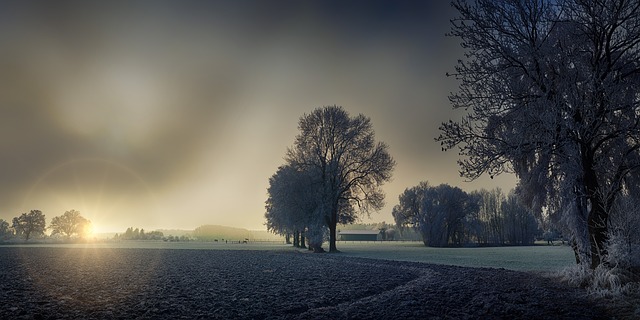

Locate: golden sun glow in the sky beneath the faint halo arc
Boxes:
[23,158,157,235]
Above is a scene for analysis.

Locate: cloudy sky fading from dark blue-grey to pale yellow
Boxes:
[0,0,515,232]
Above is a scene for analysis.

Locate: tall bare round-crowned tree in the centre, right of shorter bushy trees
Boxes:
[286,106,395,252]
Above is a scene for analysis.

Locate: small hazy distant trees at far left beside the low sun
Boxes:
[0,210,92,241]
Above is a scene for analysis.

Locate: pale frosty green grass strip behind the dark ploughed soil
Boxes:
[0,241,575,272]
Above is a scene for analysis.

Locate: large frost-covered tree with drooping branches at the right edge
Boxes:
[437,0,640,269]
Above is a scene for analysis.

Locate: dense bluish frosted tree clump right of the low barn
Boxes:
[392,182,540,247]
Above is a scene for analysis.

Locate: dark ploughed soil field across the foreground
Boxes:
[0,247,629,319]
